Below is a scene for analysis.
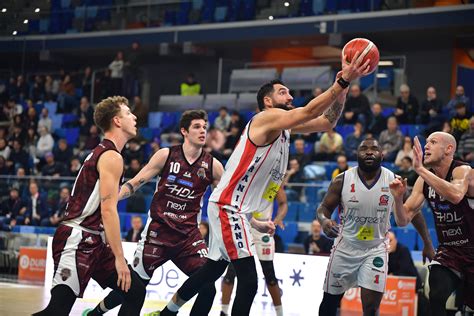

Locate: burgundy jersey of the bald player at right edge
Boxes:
[423,160,474,248]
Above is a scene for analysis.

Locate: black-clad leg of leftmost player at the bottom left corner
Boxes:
[33,284,76,316]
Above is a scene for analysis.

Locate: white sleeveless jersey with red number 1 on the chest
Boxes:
[335,167,395,248]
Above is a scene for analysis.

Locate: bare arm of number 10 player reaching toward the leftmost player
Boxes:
[119,148,170,200]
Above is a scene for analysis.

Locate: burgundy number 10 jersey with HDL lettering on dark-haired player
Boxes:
[149,145,213,241]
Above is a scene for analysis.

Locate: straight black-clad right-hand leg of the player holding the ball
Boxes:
[232,257,258,316]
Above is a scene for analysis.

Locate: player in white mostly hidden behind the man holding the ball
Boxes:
[221,187,288,316]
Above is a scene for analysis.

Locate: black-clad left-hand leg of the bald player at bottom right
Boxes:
[428,264,460,316]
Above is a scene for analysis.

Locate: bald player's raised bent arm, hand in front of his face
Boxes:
[413,137,473,204]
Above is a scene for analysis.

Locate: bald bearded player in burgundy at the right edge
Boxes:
[390,132,474,316]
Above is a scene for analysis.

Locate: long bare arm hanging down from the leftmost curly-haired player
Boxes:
[97,150,131,291]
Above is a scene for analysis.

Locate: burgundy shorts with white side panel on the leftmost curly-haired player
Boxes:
[53,225,116,297]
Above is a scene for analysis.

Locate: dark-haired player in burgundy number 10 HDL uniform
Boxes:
[87,110,224,316]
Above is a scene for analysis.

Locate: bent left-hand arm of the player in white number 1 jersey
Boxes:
[316,173,344,237]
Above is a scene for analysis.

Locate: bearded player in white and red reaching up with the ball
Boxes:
[150,53,370,315]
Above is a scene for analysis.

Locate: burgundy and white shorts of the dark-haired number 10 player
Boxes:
[133,219,207,280]
